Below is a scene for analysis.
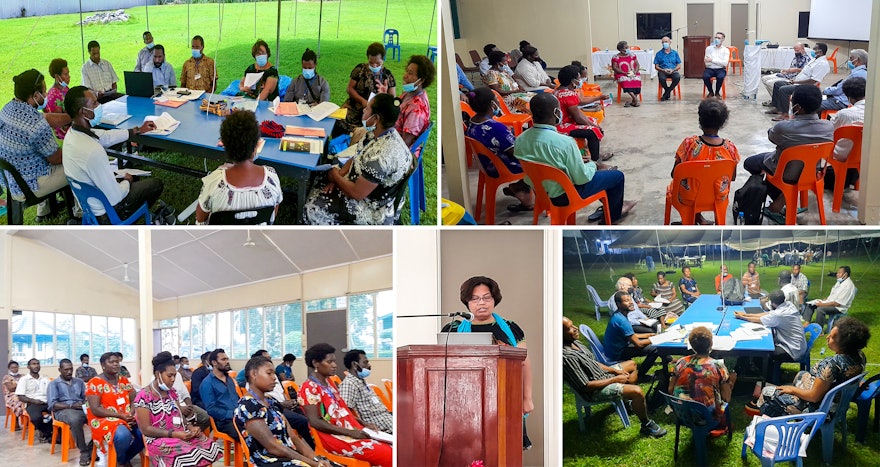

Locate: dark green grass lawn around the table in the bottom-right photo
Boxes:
[562,252,880,466]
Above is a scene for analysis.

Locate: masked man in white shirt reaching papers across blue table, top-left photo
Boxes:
[62,86,163,223]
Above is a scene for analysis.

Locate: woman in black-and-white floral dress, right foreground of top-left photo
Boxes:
[305,94,413,225]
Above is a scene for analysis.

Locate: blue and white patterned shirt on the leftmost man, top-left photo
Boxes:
[0,99,58,197]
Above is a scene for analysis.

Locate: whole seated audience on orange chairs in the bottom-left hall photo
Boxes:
[3,344,393,467]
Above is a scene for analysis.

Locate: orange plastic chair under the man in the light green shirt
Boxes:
[520,160,611,225]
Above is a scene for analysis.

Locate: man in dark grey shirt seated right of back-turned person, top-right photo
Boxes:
[743,85,834,218]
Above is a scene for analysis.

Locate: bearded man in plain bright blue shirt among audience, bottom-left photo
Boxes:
[199,349,239,439]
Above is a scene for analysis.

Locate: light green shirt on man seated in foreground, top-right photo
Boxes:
[513,123,596,198]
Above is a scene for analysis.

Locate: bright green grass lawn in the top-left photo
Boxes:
[0,0,437,225]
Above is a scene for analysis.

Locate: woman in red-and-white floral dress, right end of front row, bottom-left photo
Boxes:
[298,344,392,467]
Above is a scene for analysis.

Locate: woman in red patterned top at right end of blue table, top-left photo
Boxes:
[395,55,436,148]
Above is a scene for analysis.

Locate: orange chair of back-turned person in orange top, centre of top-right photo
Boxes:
[663,160,736,225]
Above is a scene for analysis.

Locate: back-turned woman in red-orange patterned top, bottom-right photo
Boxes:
[669,326,736,422]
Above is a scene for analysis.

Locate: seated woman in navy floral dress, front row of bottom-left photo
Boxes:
[233,355,331,467]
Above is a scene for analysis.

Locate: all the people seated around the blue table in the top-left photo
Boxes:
[0,31,436,224]
